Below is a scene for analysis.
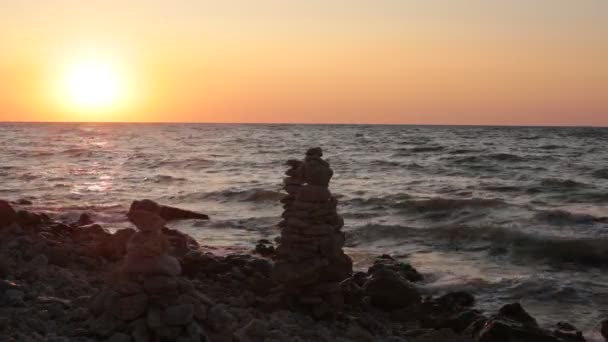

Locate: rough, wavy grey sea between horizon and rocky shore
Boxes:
[0,123,608,330]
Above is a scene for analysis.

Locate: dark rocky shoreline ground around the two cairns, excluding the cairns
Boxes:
[0,202,601,342]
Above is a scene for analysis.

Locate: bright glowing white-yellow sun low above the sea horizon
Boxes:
[58,57,127,113]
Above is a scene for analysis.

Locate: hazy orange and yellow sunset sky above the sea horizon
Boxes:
[0,0,608,126]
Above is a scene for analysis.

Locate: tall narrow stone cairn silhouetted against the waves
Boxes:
[272,147,352,316]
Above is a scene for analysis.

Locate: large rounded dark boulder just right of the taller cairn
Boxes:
[363,270,421,310]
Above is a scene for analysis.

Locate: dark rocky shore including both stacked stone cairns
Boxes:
[0,149,608,342]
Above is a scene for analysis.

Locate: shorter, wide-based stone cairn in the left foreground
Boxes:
[89,211,211,342]
